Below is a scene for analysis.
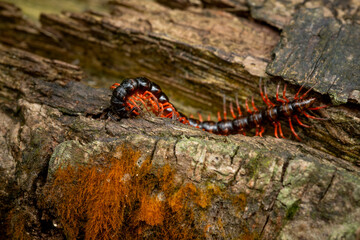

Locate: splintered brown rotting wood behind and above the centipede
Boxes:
[0,0,360,164]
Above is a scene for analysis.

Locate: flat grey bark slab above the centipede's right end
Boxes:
[267,9,360,104]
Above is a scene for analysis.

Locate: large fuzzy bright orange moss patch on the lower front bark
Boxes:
[46,147,210,239]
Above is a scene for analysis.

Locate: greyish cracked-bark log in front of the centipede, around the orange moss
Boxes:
[0,45,360,239]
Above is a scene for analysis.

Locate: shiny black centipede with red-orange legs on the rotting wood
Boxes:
[109,77,328,141]
